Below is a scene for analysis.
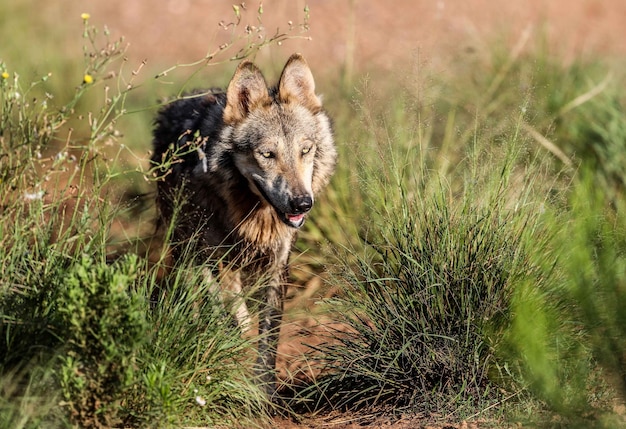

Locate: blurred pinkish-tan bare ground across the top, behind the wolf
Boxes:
[0,0,626,78]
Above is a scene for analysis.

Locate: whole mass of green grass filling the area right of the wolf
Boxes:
[296,35,626,427]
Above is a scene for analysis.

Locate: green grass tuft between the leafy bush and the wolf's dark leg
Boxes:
[122,260,269,427]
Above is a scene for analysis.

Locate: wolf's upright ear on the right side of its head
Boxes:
[278,54,322,113]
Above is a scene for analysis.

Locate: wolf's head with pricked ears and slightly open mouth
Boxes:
[223,54,336,228]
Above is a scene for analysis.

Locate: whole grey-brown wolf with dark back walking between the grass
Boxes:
[151,54,337,399]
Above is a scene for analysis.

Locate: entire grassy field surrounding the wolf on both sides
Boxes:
[0,6,626,428]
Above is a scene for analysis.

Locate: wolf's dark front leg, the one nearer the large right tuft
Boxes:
[257,276,285,402]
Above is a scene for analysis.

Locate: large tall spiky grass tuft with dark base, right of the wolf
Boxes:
[294,72,546,414]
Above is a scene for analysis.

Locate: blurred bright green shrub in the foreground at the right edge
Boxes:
[506,172,626,427]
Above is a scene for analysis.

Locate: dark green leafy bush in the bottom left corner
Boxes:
[0,229,150,427]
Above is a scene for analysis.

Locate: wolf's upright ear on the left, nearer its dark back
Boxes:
[224,61,269,124]
